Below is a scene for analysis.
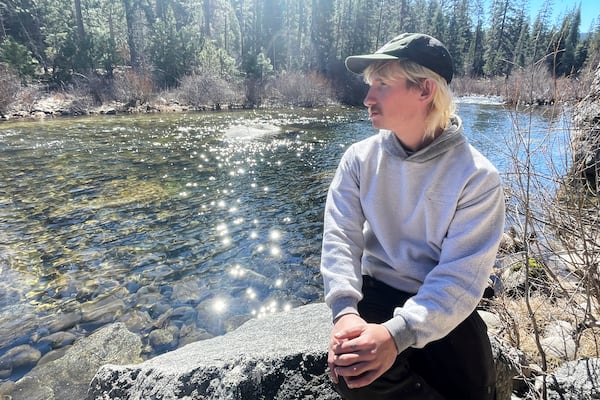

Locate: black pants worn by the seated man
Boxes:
[335,276,496,400]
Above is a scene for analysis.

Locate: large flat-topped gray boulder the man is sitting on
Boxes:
[87,303,518,400]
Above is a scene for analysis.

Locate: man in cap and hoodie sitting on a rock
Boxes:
[321,33,504,400]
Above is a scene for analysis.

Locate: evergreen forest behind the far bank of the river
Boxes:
[0,0,600,111]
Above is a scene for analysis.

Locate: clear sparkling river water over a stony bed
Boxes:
[0,102,568,380]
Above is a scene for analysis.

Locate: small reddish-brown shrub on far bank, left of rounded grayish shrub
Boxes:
[113,70,154,106]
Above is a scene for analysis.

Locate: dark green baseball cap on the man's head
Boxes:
[346,33,454,83]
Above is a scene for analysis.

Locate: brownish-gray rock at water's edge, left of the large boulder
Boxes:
[0,323,142,400]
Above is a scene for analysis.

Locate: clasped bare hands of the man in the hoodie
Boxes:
[327,314,397,389]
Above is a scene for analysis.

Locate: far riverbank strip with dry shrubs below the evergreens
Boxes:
[0,67,594,121]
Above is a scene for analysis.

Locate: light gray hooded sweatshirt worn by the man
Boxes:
[321,117,504,352]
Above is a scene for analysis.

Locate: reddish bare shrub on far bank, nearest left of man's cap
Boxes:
[266,72,335,107]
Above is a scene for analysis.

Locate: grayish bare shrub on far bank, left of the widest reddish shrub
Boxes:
[177,74,243,108]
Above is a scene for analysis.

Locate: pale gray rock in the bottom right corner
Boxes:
[547,358,600,400]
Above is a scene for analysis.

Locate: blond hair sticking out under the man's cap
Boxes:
[364,60,456,140]
